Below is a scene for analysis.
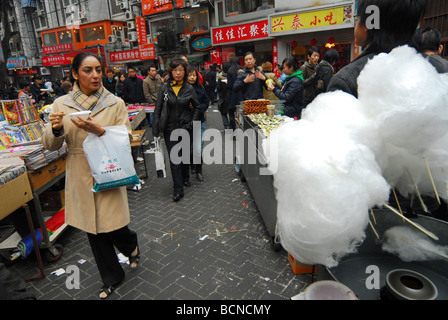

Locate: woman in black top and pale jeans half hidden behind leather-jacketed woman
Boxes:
[187,66,210,182]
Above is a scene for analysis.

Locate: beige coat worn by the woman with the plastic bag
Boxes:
[42,90,131,234]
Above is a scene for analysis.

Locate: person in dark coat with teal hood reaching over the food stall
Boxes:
[268,57,303,119]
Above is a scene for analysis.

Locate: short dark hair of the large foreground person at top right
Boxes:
[357,0,426,53]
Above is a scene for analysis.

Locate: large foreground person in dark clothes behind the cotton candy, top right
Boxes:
[327,0,426,98]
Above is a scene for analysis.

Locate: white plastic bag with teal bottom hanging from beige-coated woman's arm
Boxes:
[83,125,140,192]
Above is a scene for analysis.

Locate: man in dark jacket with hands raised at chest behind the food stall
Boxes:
[233,52,266,100]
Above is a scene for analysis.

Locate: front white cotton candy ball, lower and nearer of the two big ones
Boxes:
[274,119,389,266]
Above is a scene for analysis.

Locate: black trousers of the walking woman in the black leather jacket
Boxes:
[165,132,192,195]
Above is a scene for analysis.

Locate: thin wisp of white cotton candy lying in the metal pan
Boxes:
[381,226,448,262]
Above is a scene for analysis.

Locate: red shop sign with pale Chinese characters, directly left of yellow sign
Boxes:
[212,20,269,46]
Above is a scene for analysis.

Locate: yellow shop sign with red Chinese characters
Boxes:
[270,6,353,34]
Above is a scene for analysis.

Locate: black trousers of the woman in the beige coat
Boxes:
[87,226,138,286]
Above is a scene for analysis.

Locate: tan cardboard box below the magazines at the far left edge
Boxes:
[0,173,33,220]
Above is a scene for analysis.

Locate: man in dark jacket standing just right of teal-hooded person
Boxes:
[300,46,320,107]
